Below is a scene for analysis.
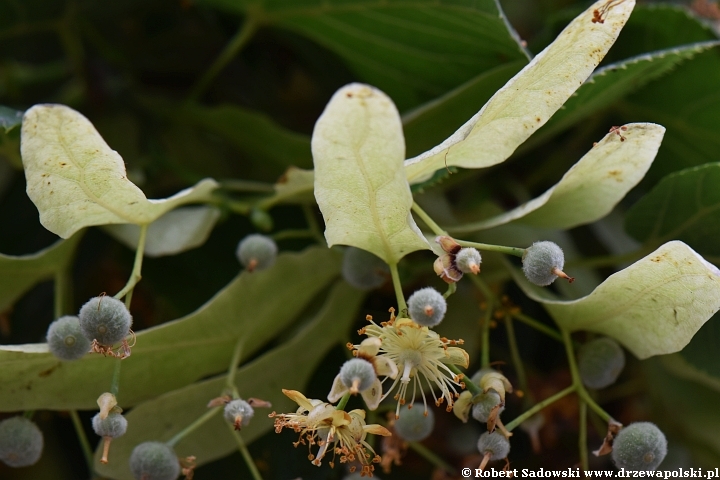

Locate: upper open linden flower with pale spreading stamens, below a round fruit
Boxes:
[355,310,470,418]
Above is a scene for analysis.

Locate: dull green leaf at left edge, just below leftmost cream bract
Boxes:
[0,235,82,312]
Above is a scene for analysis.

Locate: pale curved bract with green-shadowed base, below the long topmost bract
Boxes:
[448,123,665,233]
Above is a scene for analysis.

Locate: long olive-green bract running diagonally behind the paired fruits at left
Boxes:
[0,248,340,411]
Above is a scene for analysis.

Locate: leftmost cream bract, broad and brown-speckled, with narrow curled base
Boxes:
[21,105,217,238]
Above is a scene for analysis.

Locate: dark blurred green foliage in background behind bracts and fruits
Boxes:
[0,0,720,479]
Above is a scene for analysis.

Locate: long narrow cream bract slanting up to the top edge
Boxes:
[406,0,635,183]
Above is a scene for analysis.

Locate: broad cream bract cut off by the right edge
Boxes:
[513,241,720,358]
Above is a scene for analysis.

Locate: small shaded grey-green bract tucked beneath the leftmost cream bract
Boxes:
[104,206,220,257]
